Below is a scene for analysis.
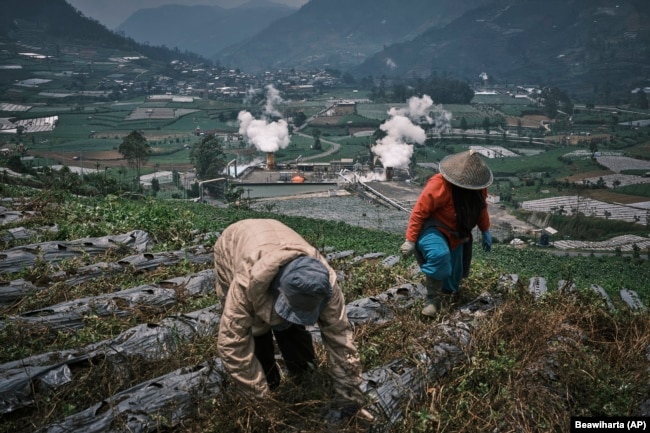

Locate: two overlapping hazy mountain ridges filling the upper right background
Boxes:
[210,0,650,101]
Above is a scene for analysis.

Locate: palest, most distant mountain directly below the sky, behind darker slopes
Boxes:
[116,0,297,57]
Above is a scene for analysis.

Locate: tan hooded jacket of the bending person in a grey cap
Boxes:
[214,219,363,403]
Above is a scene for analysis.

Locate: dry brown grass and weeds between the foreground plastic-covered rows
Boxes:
[0,208,650,433]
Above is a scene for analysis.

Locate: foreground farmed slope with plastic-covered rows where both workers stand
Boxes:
[0,183,650,433]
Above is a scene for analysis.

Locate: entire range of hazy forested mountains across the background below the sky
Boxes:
[0,0,650,99]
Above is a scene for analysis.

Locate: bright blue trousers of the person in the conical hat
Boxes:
[416,226,464,293]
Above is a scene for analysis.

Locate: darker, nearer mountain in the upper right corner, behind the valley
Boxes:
[355,0,650,95]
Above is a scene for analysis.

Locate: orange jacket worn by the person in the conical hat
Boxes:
[406,173,490,250]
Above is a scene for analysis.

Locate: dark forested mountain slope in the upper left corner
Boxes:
[0,0,206,61]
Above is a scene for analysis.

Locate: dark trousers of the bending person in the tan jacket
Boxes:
[254,325,316,389]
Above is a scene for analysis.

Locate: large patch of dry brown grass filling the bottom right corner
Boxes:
[403,286,650,433]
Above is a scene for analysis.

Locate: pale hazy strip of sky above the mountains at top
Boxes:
[66,0,308,29]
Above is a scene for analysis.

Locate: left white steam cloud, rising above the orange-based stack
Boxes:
[237,86,290,152]
